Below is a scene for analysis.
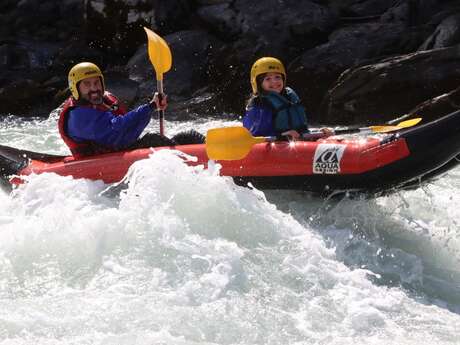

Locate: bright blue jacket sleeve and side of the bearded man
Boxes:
[67,104,152,150]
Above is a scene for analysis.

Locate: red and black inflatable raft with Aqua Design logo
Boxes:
[0,112,460,193]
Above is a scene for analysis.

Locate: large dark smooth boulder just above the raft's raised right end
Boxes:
[321,46,460,124]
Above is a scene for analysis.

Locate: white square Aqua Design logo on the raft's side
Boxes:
[313,144,345,174]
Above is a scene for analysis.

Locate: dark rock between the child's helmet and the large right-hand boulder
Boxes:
[288,23,429,122]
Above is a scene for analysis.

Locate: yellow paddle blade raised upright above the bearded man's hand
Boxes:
[144,26,172,80]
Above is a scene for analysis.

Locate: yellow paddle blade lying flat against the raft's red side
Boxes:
[206,127,266,160]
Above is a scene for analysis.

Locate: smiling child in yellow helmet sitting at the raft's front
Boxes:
[243,57,332,139]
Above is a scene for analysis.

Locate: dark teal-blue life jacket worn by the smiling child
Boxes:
[259,87,308,133]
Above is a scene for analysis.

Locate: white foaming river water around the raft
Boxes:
[0,113,460,345]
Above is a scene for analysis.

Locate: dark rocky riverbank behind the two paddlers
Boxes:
[0,0,460,125]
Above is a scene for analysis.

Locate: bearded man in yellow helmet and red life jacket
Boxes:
[59,62,174,158]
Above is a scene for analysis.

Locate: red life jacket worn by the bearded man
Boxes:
[58,91,126,158]
